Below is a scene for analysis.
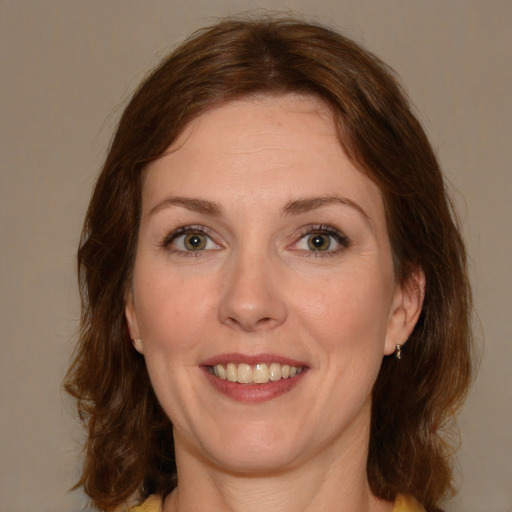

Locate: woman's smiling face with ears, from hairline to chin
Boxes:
[126,95,420,472]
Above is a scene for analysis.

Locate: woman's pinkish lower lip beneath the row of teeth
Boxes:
[204,367,307,403]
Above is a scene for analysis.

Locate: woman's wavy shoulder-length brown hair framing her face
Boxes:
[65,18,471,512]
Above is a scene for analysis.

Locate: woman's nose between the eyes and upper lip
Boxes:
[219,251,287,332]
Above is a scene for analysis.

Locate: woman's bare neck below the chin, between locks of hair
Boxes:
[164,410,392,512]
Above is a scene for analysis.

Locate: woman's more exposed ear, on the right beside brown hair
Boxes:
[384,267,425,355]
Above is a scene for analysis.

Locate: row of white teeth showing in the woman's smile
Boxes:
[210,363,304,384]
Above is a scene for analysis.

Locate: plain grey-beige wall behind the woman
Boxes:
[0,0,512,512]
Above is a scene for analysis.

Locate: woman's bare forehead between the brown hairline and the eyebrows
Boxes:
[143,95,382,222]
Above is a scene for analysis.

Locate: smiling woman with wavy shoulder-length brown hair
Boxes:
[66,15,471,512]
